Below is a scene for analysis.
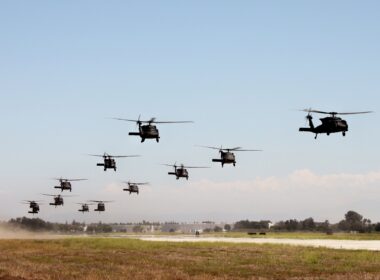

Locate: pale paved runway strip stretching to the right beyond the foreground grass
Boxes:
[139,236,380,251]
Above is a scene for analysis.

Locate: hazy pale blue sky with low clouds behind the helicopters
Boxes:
[0,0,380,222]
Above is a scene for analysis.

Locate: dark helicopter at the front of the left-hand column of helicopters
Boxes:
[113,116,193,143]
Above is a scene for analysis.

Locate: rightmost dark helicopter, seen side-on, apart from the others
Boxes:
[299,109,372,139]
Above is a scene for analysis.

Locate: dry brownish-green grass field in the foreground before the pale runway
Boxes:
[0,238,380,280]
